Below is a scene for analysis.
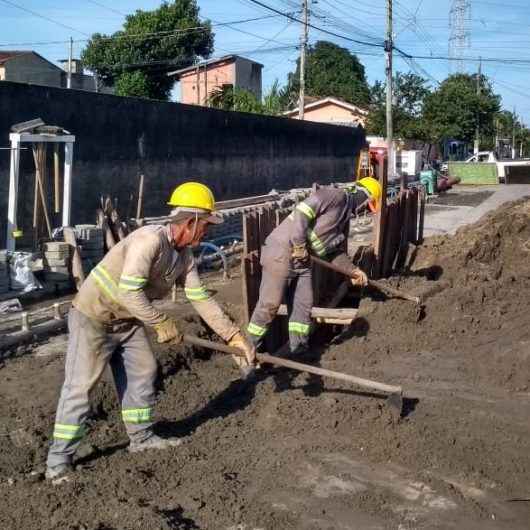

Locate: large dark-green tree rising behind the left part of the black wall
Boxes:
[81,0,213,100]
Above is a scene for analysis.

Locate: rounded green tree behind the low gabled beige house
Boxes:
[283,41,370,108]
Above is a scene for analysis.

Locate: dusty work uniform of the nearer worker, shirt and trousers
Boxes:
[48,225,239,467]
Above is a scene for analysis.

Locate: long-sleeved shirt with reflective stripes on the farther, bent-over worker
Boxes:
[267,187,366,266]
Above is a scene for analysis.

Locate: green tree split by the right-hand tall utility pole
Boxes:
[366,72,430,140]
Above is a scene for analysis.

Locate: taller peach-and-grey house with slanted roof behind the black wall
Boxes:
[168,55,263,106]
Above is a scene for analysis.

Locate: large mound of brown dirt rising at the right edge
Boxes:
[346,199,530,392]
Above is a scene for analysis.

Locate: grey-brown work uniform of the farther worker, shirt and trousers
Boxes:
[247,187,367,352]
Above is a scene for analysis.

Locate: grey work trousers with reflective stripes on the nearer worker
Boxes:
[48,308,157,466]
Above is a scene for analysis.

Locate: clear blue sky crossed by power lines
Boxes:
[0,0,530,125]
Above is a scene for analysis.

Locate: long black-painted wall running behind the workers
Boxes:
[0,82,364,247]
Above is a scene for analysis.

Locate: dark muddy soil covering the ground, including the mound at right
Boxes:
[0,201,530,530]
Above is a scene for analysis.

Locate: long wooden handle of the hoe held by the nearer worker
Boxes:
[184,335,403,394]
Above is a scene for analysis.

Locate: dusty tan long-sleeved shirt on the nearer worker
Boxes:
[73,225,239,340]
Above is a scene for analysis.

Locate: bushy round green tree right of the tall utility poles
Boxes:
[423,74,501,142]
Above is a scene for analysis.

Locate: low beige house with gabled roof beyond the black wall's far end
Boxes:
[284,97,368,127]
